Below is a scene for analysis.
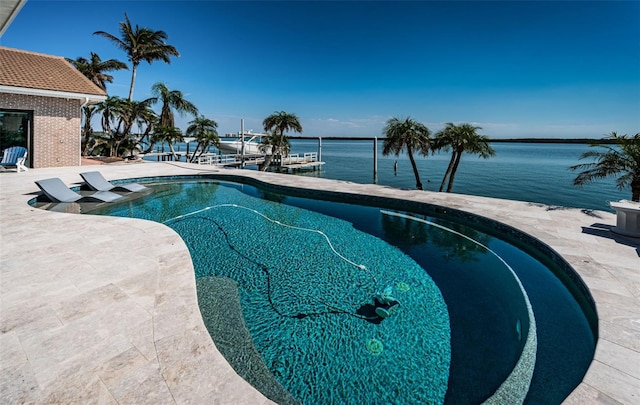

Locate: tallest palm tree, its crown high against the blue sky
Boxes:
[93,13,180,101]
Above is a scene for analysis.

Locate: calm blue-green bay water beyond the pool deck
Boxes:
[290,139,631,212]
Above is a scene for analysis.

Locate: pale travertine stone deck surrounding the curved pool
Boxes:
[0,162,640,404]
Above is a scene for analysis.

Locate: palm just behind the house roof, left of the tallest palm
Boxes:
[66,52,127,156]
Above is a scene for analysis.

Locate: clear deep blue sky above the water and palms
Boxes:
[0,0,640,138]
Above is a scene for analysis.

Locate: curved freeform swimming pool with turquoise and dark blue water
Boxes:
[75,175,594,403]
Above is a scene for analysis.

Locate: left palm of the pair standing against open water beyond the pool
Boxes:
[382,117,431,190]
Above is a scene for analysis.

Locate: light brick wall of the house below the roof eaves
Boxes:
[0,93,82,168]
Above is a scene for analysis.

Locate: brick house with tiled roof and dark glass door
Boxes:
[0,46,107,168]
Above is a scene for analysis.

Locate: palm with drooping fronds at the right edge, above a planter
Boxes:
[570,132,640,201]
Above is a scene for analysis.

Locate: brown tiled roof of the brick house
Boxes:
[0,46,106,96]
